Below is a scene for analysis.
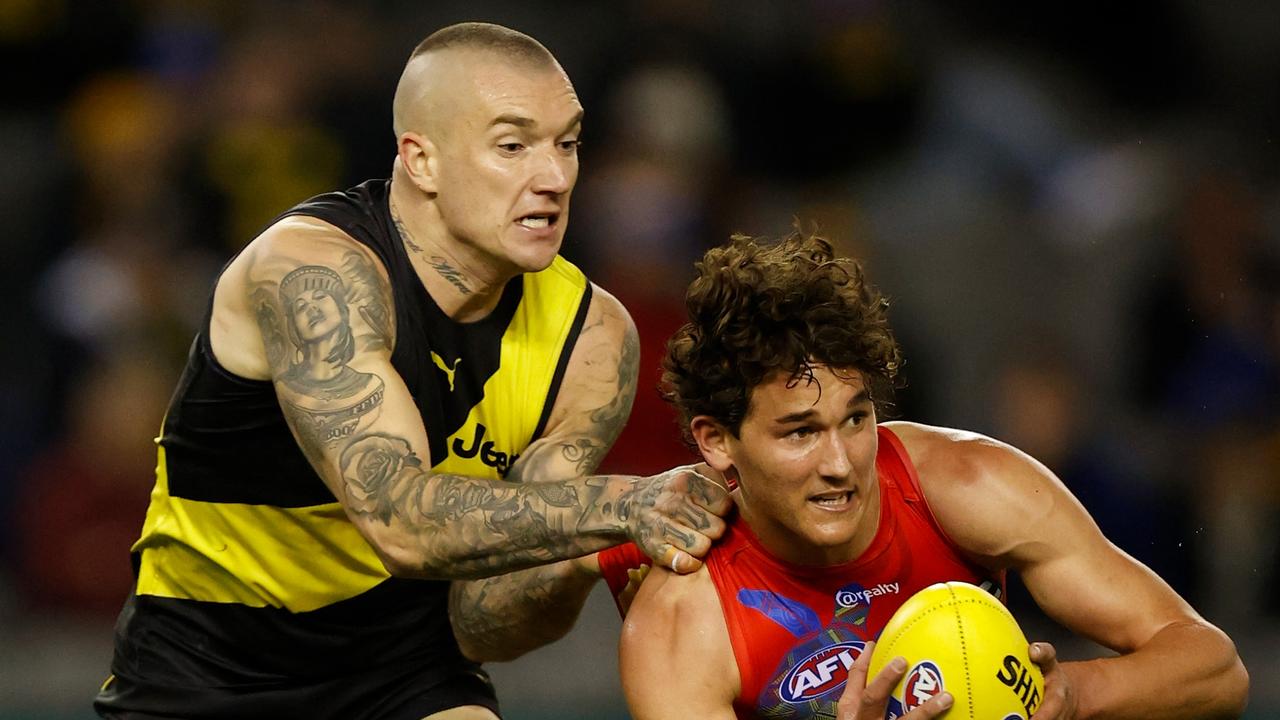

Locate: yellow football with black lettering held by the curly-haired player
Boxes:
[867,583,1044,720]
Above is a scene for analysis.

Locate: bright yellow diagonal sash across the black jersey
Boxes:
[133,258,586,612]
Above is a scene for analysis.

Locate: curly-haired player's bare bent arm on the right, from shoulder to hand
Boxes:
[892,423,1248,720]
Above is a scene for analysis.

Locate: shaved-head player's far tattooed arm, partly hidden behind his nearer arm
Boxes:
[449,287,640,661]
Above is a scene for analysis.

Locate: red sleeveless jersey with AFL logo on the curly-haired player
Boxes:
[600,427,1004,719]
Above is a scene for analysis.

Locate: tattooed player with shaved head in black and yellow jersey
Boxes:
[95,23,732,720]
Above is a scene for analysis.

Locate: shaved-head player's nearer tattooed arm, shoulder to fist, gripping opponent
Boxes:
[212,219,728,579]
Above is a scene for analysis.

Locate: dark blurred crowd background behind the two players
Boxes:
[0,0,1280,720]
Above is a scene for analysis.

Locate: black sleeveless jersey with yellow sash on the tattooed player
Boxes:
[101,181,590,716]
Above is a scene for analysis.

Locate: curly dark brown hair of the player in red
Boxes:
[662,232,902,450]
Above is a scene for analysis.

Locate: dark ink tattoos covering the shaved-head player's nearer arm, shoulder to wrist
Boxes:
[250,245,617,578]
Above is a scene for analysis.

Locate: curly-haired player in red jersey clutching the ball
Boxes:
[598,233,1248,720]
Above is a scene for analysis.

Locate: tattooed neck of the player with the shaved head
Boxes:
[390,170,518,323]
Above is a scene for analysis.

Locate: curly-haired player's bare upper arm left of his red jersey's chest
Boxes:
[618,568,741,720]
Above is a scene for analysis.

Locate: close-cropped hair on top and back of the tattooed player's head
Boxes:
[392,23,559,137]
